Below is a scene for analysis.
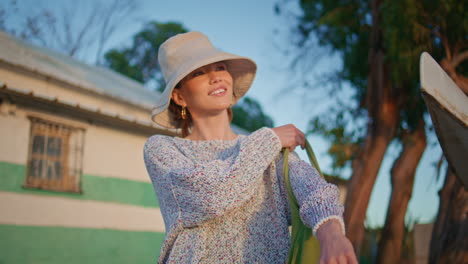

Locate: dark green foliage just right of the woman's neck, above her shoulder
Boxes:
[232,96,274,132]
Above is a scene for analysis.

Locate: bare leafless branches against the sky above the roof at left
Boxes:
[0,0,138,64]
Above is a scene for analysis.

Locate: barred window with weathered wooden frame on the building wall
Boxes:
[25,117,84,192]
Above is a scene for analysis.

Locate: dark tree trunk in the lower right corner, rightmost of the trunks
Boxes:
[429,168,468,264]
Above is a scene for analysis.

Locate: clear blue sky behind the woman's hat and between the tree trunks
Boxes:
[14,0,443,226]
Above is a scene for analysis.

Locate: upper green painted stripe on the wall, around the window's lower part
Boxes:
[0,162,159,208]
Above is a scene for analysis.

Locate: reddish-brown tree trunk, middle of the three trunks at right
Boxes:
[377,118,426,264]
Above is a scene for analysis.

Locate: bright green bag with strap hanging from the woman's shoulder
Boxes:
[283,140,323,263]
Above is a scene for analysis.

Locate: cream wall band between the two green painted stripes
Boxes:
[0,191,164,232]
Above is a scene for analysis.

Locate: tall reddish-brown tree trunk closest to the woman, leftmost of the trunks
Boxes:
[344,0,398,256]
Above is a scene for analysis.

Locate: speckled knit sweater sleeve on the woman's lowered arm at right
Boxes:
[277,152,345,235]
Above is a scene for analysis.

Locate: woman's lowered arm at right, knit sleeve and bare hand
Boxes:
[280,152,357,264]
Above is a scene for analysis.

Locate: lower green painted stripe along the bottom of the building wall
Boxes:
[0,225,164,264]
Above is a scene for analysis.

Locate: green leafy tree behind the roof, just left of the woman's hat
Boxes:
[104,21,187,91]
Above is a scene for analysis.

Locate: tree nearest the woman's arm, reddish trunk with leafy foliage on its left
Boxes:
[278,0,399,254]
